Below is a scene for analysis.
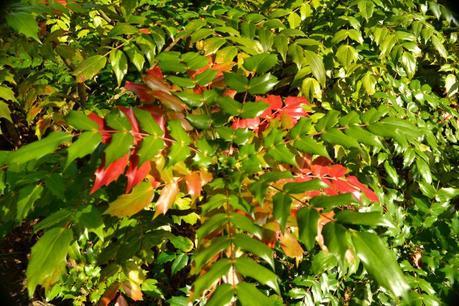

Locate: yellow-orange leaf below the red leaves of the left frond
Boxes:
[105,182,153,217]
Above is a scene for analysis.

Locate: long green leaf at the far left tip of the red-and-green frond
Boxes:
[8,132,72,165]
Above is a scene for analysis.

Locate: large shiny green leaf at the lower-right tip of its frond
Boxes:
[351,232,410,296]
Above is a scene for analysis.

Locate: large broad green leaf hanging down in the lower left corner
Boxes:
[26,228,73,297]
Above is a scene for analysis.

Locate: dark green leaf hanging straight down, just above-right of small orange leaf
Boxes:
[296,207,320,251]
